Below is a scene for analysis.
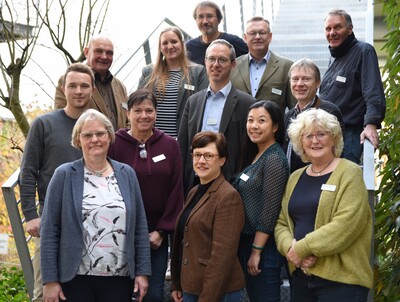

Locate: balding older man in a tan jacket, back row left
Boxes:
[54,36,128,130]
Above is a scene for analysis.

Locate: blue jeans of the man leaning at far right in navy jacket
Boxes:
[342,126,364,164]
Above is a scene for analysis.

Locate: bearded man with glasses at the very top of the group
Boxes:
[186,1,248,65]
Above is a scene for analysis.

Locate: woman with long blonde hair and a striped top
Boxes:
[138,27,208,137]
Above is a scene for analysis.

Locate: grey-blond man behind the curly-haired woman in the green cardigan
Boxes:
[283,59,344,173]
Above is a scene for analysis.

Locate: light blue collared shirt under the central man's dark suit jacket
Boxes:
[201,81,232,132]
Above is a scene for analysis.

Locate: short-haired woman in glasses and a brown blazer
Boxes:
[171,131,245,302]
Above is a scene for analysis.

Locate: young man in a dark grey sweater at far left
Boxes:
[19,63,94,301]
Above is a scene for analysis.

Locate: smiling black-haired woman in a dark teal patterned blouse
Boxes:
[233,101,289,302]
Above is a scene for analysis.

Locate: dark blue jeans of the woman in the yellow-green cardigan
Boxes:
[291,269,369,302]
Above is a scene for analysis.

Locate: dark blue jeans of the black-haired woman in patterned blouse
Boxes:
[238,235,284,302]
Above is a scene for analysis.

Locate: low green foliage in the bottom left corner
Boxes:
[0,267,29,302]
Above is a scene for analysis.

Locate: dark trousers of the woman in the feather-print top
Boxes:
[61,275,134,302]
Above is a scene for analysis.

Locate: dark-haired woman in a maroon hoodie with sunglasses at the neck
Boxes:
[108,88,183,302]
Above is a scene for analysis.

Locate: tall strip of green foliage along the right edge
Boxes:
[374,0,400,302]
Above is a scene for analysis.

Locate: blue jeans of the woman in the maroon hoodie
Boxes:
[143,237,168,302]
